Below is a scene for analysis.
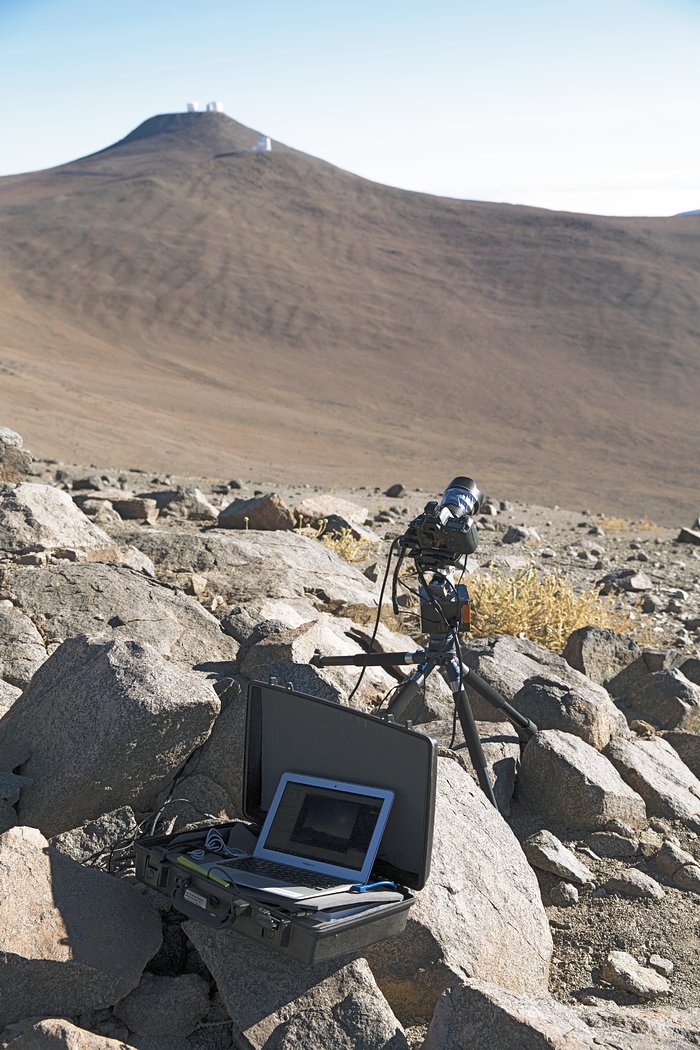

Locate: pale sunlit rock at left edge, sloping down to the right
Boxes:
[0,482,119,561]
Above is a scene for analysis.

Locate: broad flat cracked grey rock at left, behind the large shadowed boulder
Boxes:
[1,564,238,667]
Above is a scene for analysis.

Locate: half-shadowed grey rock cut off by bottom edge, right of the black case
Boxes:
[422,980,593,1050]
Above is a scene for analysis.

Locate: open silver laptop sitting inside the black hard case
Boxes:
[179,773,394,900]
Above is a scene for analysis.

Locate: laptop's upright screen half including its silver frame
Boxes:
[255,774,393,879]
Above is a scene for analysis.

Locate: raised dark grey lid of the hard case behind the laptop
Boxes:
[243,681,438,889]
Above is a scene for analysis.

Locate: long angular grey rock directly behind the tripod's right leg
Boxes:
[463,635,627,750]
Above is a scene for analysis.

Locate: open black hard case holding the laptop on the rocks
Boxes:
[135,683,437,965]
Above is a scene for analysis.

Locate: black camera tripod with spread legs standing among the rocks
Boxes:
[311,569,537,810]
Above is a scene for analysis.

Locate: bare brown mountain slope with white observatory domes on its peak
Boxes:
[0,113,700,519]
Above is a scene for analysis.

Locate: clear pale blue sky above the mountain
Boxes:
[0,0,700,215]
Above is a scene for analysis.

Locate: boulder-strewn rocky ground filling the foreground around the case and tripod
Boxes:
[0,432,700,1050]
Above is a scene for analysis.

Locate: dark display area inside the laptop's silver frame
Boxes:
[266,782,382,867]
